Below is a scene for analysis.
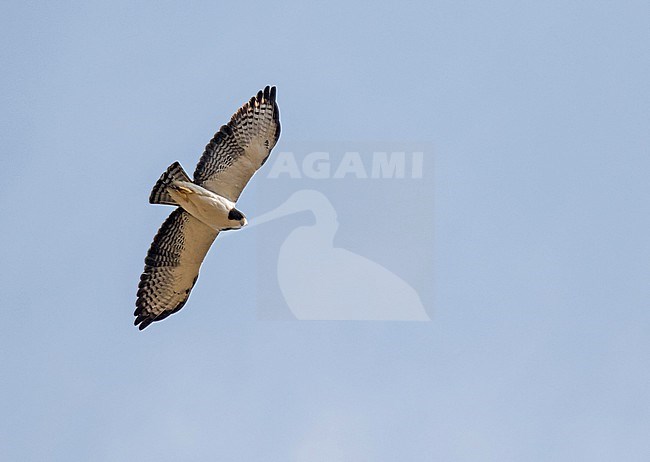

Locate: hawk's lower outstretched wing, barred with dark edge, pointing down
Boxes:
[133,207,219,330]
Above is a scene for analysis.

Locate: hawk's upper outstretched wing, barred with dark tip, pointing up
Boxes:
[194,86,280,202]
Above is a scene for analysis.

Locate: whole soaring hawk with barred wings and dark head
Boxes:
[134,86,280,330]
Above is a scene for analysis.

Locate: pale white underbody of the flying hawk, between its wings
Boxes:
[168,181,246,231]
